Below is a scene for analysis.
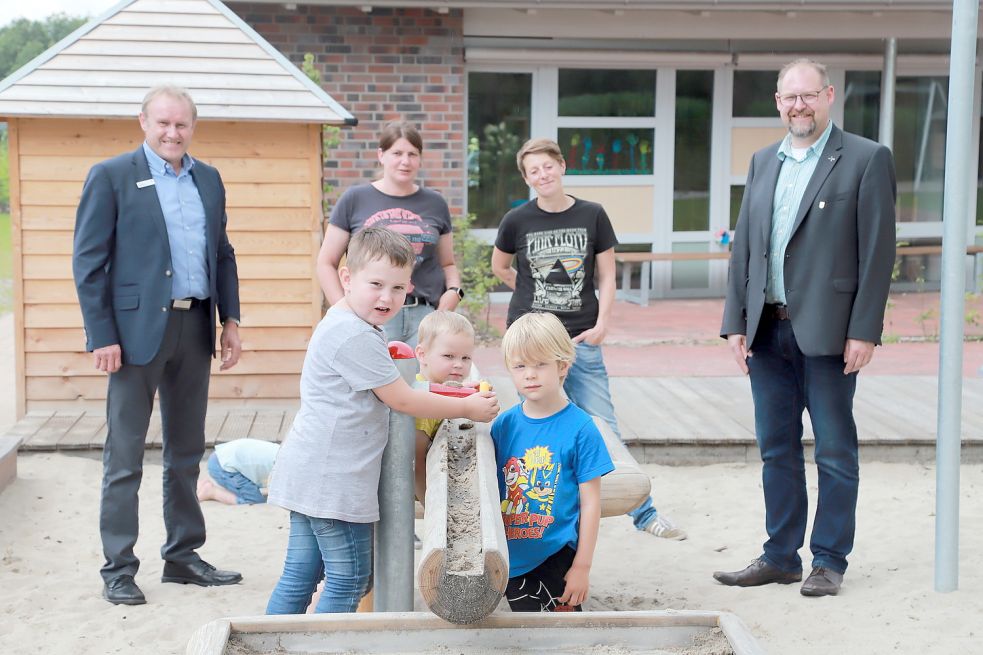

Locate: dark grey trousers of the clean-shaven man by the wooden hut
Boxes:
[99,302,212,581]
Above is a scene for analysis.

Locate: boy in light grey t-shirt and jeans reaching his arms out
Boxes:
[266,227,498,614]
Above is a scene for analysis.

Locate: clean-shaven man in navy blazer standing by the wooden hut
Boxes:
[72,86,242,605]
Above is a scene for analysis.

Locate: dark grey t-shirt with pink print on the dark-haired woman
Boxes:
[331,184,451,307]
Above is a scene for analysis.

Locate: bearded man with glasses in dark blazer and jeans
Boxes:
[713,59,897,596]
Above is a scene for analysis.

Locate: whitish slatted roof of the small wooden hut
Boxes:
[0,0,356,124]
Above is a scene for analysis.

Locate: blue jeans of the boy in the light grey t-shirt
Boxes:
[266,512,372,614]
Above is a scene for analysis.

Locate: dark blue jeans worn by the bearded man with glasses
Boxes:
[748,319,860,573]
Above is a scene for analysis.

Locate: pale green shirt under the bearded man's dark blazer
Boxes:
[765,121,833,305]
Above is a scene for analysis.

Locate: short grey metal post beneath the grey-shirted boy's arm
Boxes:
[372,359,417,612]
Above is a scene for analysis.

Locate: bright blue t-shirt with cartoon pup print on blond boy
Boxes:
[491,403,614,578]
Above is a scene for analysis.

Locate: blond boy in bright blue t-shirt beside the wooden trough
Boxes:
[491,312,614,612]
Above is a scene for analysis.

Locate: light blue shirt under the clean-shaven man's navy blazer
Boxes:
[143,142,208,299]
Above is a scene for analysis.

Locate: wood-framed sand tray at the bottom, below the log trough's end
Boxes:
[187,610,764,655]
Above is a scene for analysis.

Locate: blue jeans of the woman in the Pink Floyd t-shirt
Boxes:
[563,341,659,530]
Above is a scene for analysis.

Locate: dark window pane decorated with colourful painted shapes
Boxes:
[557,127,655,175]
